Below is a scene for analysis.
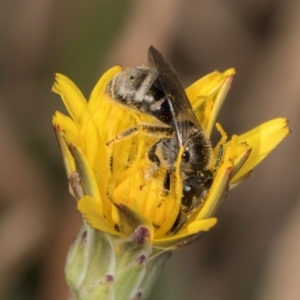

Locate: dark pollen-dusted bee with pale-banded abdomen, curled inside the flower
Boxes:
[107,46,214,233]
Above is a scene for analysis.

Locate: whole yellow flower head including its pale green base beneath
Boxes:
[52,47,289,300]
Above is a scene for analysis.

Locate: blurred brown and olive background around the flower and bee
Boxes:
[0,0,300,300]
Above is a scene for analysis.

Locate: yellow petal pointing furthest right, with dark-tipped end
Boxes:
[231,118,290,182]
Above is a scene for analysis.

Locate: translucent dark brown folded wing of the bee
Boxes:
[148,46,202,146]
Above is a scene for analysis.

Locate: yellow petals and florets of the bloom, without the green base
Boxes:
[52,66,289,249]
